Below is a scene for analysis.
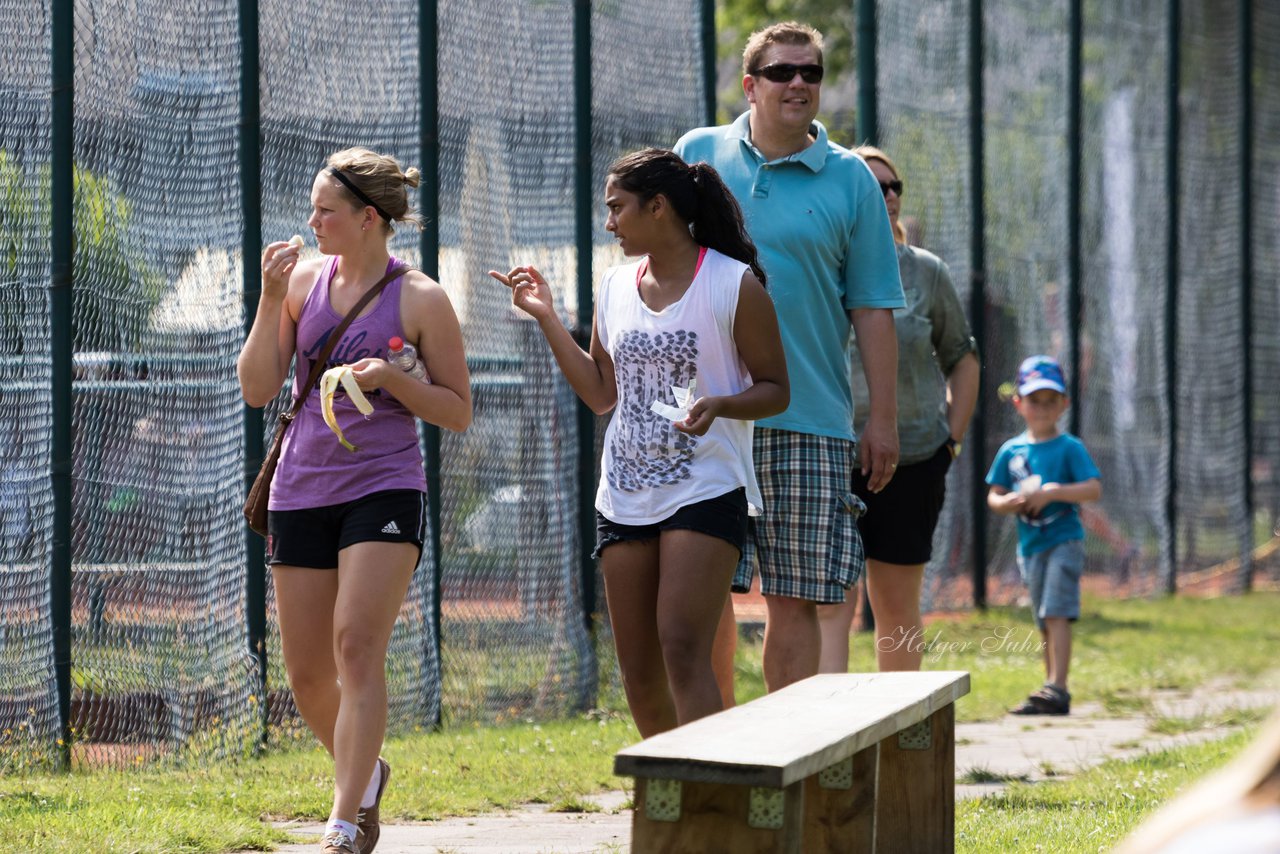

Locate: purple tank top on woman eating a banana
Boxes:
[268,257,426,510]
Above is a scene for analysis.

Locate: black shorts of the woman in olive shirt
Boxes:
[854,444,951,566]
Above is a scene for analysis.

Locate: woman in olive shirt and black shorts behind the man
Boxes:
[818,146,978,673]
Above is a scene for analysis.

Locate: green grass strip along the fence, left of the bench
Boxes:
[0,714,639,854]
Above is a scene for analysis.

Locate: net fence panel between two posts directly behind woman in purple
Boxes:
[253,0,440,744]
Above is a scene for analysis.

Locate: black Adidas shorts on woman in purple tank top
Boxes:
[266,489,426,570]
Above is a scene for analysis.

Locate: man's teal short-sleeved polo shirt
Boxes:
[676,113,906,439]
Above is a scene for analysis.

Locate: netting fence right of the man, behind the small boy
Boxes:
[863,0,1280,609]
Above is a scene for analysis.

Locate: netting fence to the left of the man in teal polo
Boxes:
[0,0,703,768]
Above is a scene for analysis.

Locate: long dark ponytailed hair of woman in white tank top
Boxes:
[609,149,764,284]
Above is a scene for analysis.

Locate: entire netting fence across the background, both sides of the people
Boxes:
[0,0,1280,769]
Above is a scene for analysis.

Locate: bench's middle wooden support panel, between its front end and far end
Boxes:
[804,745,879,854]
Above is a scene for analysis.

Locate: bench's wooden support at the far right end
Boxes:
[876,704,956,854]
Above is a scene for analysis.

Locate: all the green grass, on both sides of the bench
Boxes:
[0,594,1280,854]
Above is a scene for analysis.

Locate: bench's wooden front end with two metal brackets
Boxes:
[631,777,805,854]
